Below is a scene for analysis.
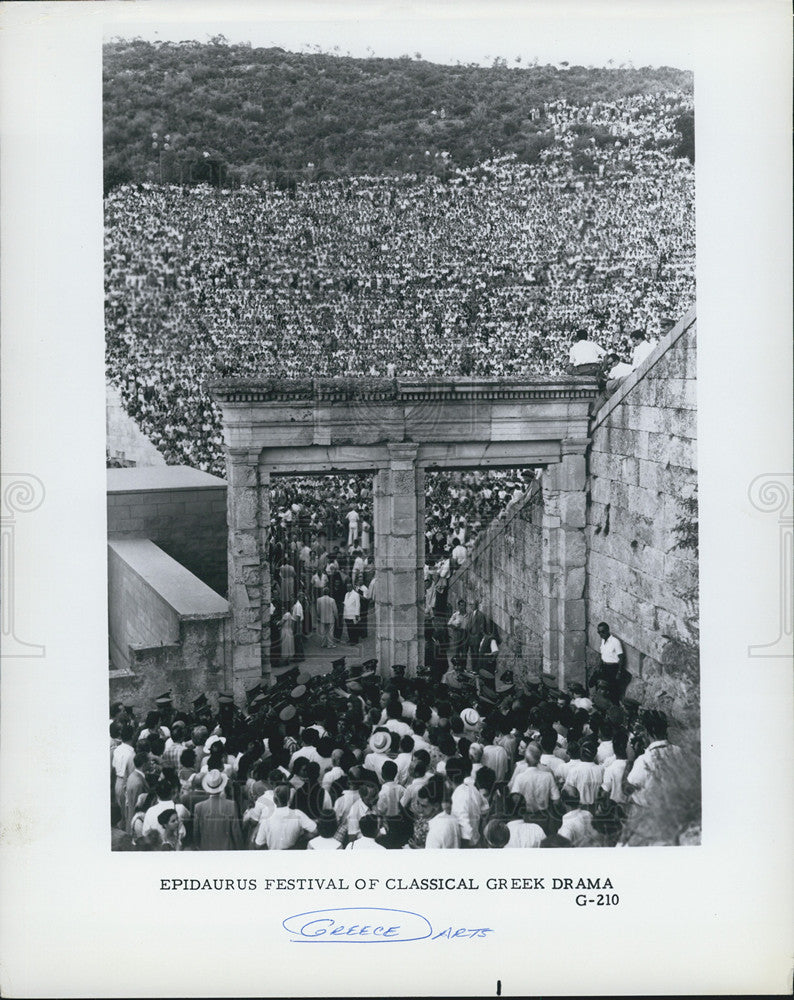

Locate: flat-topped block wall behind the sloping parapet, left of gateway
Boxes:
[107,465,227,596]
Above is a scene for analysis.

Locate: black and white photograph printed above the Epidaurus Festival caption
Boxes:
[103,23,700,851]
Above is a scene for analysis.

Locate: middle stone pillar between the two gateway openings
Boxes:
[373,443,425,677]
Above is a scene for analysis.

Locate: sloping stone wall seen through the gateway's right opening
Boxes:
[449,483,543,682]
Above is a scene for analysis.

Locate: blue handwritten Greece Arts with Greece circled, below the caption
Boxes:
[282,906,492,944]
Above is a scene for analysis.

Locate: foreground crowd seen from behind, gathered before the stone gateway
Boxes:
[110,632,698,851]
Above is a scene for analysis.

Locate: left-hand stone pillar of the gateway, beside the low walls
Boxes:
[226,449,270,697]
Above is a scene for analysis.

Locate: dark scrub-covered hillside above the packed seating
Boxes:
[104,37,694,190]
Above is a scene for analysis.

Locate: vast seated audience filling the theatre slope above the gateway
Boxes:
[105,88,695,474]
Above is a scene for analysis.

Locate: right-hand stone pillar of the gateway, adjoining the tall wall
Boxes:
[541,438,588,688]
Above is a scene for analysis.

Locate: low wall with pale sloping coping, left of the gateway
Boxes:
[108,538,229,704]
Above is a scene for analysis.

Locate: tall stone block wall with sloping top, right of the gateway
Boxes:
[587,312,699,718]
